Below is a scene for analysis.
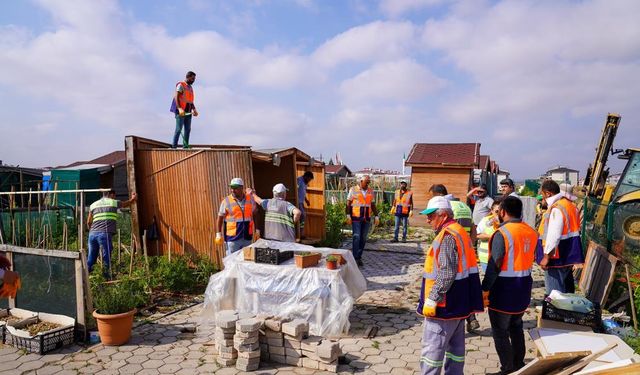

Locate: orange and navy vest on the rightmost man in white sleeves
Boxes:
[536,197,584,268]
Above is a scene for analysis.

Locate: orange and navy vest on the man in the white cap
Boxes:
[416,222,484,319]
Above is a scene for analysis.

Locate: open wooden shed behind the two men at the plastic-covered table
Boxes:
[252,147,326,243]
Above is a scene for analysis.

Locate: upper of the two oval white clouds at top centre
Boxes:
[312,21,417,67]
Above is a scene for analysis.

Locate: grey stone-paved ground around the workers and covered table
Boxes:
[0,241,543,375]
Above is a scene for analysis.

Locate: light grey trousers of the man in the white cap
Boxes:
[420,318,465,375]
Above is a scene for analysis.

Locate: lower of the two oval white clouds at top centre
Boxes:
[340,59,445,102]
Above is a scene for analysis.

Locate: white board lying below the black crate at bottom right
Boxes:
[538,329,622,362]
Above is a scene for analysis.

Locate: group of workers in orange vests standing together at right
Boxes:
[394,179,584,374]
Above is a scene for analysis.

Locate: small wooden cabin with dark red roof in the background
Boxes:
[406,143,480,225]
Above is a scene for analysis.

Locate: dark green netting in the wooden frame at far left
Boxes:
[13,253,77,318]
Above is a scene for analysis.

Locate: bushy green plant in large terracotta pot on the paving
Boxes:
[91,272,147,346]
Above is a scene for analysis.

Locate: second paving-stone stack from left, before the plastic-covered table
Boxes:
[233,318,262,371]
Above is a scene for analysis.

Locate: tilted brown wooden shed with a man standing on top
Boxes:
[125,136,253,265]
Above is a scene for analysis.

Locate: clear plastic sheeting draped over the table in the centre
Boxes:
[202,239,367,337]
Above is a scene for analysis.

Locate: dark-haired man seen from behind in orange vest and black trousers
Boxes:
[482,196,538,374]
